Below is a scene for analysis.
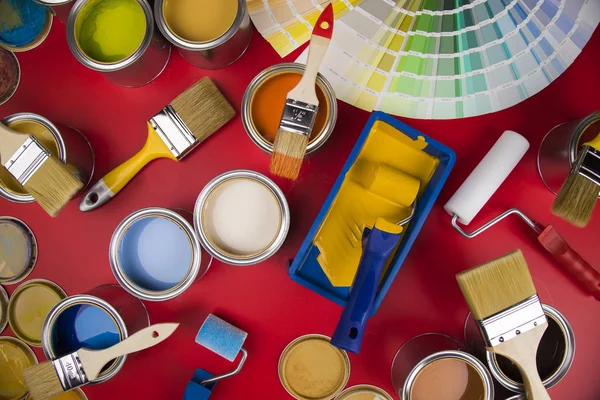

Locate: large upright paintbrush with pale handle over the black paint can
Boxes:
[456,250,550,400]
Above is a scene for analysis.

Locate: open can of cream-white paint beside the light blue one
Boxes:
[194,170,290,266]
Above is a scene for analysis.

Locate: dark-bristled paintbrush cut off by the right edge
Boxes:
[552,134,600,228]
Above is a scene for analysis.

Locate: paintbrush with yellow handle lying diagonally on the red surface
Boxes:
[79,78,235,211]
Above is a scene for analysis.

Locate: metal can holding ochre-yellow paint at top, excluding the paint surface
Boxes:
[154,0,252,69]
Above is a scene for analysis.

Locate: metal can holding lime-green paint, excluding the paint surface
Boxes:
[67,0,171,87]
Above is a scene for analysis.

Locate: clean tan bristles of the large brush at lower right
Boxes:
[456,250,536,320]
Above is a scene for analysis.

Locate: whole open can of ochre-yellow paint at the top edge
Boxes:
[154,0,252,69]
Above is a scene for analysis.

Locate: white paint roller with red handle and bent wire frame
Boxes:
[444,131,600,301]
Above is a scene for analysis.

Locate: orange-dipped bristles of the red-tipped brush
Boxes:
[271,129,308,181]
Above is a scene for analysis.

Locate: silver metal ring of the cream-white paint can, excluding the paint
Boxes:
[194,169,290,266]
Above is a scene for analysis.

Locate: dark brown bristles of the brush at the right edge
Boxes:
[552,172,600,228]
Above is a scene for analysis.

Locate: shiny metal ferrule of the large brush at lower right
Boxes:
[477,294,547,347]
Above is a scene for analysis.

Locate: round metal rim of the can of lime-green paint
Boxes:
[67,0,156,72]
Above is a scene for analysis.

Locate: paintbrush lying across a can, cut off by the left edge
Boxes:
[0,124,83,217]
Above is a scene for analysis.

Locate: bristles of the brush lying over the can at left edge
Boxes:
[23,156,83,217]
